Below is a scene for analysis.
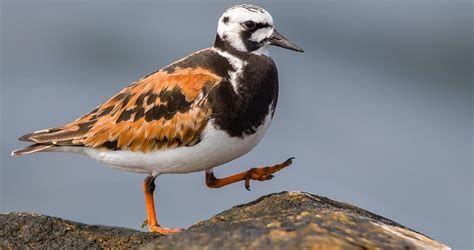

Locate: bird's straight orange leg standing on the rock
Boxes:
[143,175,183,235]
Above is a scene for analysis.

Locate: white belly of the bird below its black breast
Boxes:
[74,112,271,175]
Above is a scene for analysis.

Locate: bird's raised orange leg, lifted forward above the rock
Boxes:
[206,157,294,190]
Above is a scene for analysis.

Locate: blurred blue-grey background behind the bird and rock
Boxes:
[0,0,473,248]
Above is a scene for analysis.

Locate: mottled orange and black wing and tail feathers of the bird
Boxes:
[16,67,221,152]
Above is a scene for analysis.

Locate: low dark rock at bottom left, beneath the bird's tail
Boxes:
[0,213,161,249]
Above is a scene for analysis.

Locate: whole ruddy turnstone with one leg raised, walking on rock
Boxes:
[12,5,303,234]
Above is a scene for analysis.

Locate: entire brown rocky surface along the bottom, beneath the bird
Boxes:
[0,192,449,249]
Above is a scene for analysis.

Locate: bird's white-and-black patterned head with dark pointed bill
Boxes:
[214,4,303,54]
